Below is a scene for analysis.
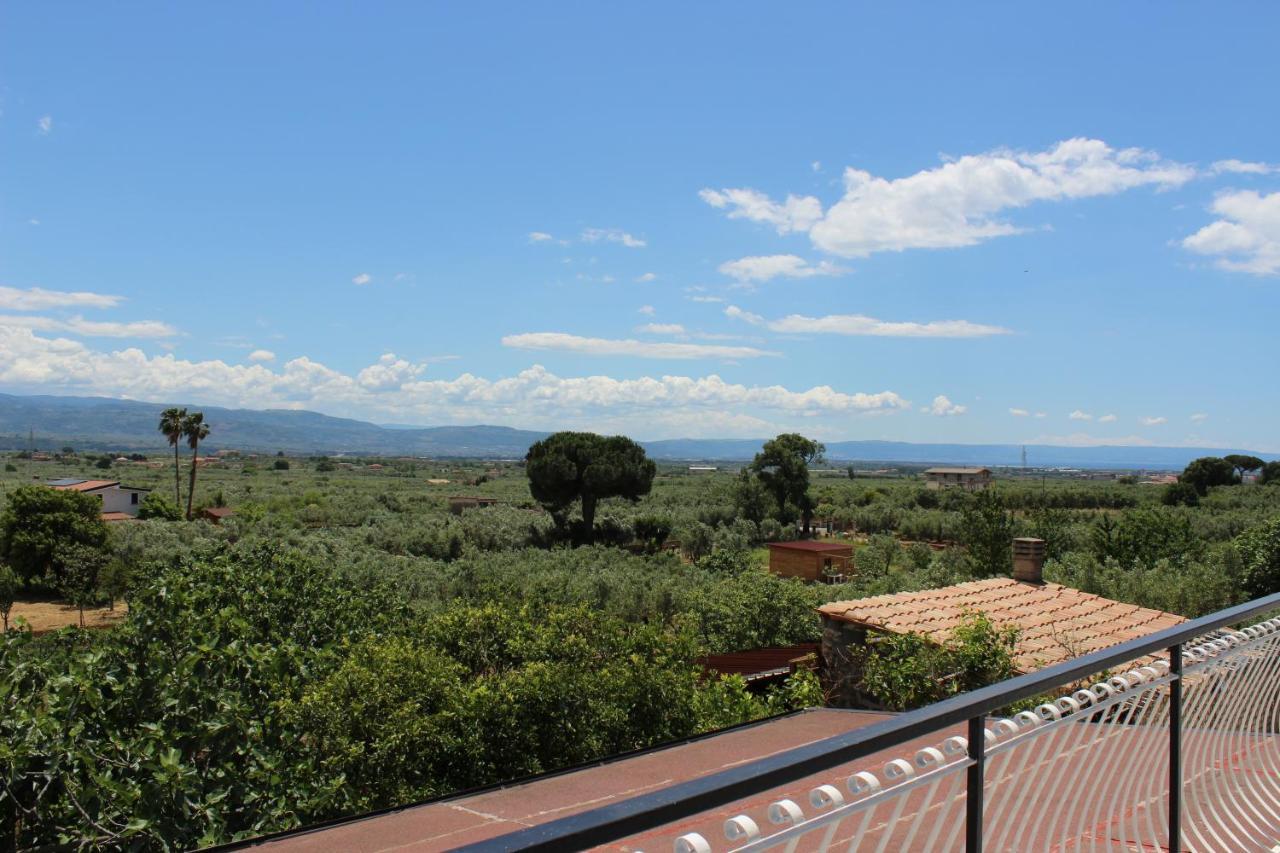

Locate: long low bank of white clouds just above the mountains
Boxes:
[0,325,910,438]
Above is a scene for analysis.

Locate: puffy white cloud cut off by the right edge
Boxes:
[1183,190,1280,275]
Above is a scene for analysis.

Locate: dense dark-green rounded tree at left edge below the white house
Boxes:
[0,485,108,584]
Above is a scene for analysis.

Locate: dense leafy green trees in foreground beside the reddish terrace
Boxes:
[0,548,814,848]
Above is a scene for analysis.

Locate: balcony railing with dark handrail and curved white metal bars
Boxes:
[466,594,1280,853]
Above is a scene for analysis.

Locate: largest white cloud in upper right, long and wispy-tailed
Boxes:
[703,138,1196,257]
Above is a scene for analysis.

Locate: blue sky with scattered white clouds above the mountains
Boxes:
[0,3,1280,452]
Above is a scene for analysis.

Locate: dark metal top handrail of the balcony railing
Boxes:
[461,593,1280,853]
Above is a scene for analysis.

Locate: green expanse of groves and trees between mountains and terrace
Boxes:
[0,445,1280,847]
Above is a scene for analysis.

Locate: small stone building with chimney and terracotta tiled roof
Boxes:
[818,539,1187,707]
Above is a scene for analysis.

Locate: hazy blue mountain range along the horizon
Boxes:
[0,394,1277,470]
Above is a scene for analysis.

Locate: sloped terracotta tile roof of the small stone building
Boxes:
[818,578,1187,672]
